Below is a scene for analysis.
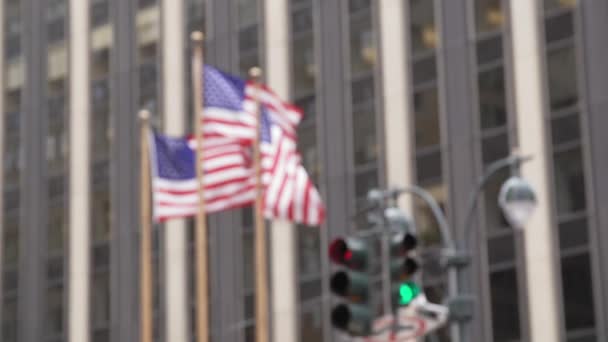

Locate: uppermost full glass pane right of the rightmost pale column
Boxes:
[547,46,578,111]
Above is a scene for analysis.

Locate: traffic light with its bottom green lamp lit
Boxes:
[390,232,421,308]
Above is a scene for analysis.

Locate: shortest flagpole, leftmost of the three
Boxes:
[139,110,153,342]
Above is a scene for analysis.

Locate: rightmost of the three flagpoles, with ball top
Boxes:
[249,67,270,342]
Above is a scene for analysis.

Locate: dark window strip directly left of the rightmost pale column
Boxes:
[474,0,521,341]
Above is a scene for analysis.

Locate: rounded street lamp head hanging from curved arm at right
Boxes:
[498,176,536,229]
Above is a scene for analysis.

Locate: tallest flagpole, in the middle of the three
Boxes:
[191,31,209,342]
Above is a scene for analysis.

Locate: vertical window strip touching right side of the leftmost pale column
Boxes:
[90,0,113,342]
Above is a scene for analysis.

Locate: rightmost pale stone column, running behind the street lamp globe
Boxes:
[510,0,560,342]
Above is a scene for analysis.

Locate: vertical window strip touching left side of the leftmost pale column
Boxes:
[45,0,69,342]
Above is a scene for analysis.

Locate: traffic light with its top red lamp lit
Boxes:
[329,237,373,336]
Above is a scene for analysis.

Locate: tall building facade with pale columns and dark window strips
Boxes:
[0,0,608,342]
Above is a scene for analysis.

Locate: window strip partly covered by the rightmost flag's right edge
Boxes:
[290,0,323,341]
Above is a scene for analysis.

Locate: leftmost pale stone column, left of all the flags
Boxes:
[68,0,91,342]
